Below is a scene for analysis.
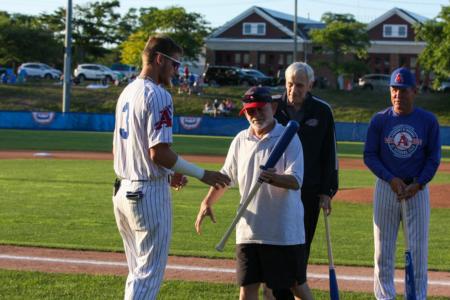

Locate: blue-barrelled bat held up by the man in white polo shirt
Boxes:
[216,121,300,251]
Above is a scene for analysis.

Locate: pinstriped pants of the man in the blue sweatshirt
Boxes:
[373,179,430,300]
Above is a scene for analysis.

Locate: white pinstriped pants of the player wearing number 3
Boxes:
[113,177,172,300]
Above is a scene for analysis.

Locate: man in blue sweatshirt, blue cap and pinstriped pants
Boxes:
[364,68,441,299]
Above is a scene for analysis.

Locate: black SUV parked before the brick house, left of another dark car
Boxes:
[203,66,244,85]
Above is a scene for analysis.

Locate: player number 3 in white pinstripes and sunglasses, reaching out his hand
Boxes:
[113,36,230,299]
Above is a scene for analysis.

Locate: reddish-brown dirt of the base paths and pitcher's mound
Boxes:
[0,151,450,297]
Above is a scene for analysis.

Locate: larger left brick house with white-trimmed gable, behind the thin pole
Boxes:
[205,6,325,75]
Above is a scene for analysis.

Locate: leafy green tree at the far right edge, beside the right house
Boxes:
[416,6,450,85]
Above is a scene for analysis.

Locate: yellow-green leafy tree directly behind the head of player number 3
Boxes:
[121,7,210,65]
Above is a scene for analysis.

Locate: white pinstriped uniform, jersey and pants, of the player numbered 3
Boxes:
[113,79,173,300]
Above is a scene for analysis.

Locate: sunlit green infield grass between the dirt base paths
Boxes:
[0,159,450,271]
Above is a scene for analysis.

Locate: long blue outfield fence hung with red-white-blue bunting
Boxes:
[0,111,450,145]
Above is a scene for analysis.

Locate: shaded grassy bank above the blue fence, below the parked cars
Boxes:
[0,81,450,125]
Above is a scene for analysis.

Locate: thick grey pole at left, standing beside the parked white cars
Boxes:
[62,0,72,113]
